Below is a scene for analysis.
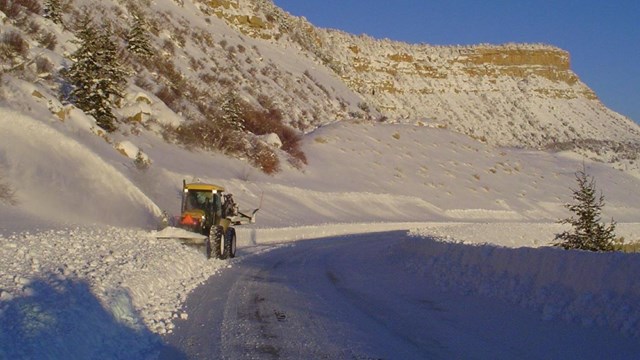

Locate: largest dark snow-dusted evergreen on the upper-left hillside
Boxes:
[65,14,126,132]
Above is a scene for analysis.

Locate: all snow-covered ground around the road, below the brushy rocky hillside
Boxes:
[0,98,640,359]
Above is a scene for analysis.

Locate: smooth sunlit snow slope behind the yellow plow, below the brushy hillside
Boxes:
[0,103,640,229]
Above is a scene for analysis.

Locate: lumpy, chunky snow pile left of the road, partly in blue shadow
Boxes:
[0,227,230,359]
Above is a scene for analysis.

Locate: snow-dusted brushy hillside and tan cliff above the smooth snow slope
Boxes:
[0,0,640,170]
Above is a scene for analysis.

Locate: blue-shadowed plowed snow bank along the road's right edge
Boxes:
[404,229,640,337]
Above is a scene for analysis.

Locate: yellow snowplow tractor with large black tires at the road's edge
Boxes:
[178,180,259,259]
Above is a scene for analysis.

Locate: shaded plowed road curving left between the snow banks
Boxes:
[161,231,640,359]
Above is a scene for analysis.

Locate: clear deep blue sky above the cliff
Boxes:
[274,0,640,123]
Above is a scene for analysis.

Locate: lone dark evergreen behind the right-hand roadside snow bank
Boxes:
[553,169,616,251]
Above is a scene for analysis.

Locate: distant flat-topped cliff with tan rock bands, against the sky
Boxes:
[212,0,640,148]
